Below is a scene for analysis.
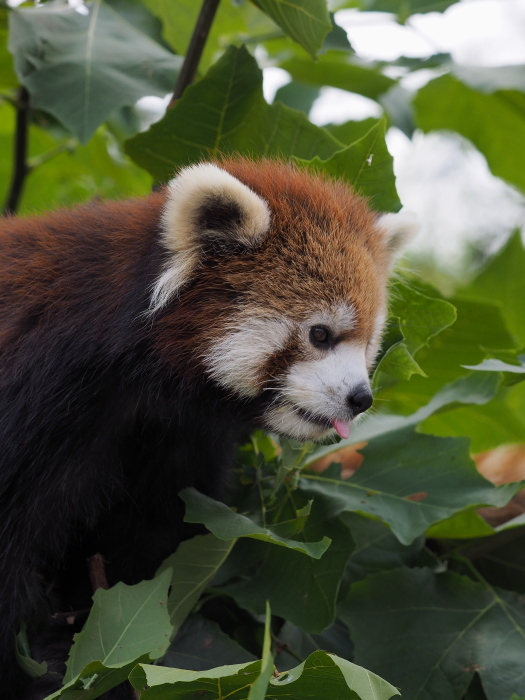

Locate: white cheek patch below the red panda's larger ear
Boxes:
[204,314,293,397]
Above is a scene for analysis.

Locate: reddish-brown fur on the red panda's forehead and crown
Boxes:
[154,159,390,374]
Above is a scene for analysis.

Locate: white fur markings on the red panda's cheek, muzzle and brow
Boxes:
[204,304,376,440]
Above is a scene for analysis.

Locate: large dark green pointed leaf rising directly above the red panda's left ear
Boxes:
[127,47,343,180]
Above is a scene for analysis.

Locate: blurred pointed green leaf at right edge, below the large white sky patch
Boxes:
[460,231,525,347]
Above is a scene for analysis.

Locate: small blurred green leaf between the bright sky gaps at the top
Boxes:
[279,51,397,100]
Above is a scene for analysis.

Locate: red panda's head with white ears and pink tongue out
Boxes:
[152,159,411,440]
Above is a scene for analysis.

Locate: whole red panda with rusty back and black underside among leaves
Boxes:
[0,159,416,700]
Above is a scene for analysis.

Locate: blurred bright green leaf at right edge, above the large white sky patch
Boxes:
[414,75,525,190]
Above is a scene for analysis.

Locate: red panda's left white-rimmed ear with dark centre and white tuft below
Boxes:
[150,163,270,311]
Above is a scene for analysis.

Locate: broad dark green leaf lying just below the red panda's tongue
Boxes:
[300,427,519,545]
